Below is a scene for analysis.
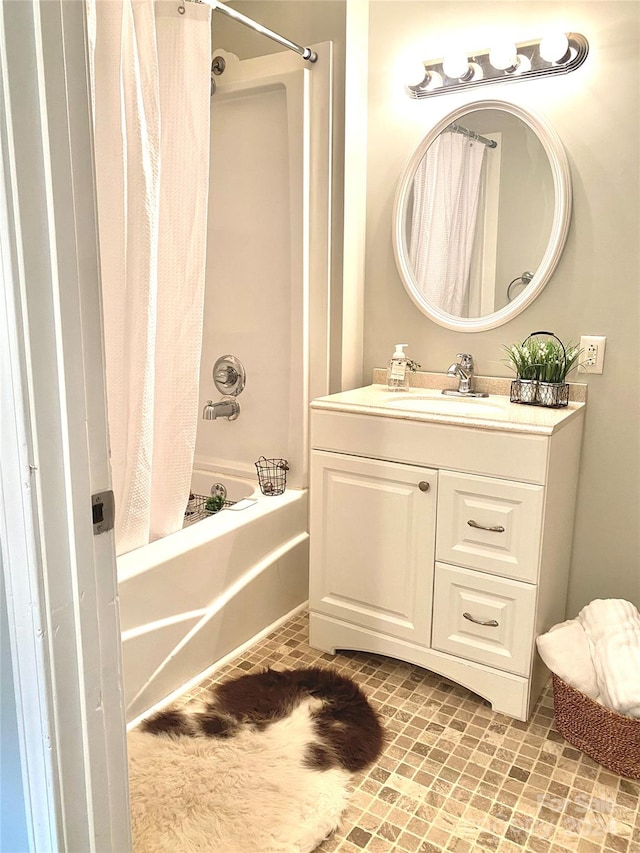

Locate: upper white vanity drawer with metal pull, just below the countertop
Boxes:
[436,471,544,583]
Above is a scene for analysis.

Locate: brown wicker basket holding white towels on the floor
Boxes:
[552,673,640,779]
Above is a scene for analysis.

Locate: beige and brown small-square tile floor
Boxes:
[176,613,640,853]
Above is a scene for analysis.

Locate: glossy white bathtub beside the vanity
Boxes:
[118,471,309,724]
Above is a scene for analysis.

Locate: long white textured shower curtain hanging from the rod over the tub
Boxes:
[88,0,211,554]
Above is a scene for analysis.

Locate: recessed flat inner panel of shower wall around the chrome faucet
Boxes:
[197,86,298,472]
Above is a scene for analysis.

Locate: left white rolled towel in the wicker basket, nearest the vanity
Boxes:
[536,619,601,702]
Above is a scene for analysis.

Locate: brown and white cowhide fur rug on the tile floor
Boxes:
[128,667,384,853]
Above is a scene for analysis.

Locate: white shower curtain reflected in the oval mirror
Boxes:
[409,133,485,317]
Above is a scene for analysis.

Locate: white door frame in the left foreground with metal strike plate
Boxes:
[0,0,130,853]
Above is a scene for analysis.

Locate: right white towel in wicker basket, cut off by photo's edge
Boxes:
[593,626,640,717]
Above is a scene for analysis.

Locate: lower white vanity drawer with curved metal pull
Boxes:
[431,563,536,675]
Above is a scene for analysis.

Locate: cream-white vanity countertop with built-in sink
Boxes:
[311,385,586,435]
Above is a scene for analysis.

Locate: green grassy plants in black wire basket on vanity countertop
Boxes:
[505,332,580,409]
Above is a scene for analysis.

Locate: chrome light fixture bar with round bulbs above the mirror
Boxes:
[407,33,589,98]
